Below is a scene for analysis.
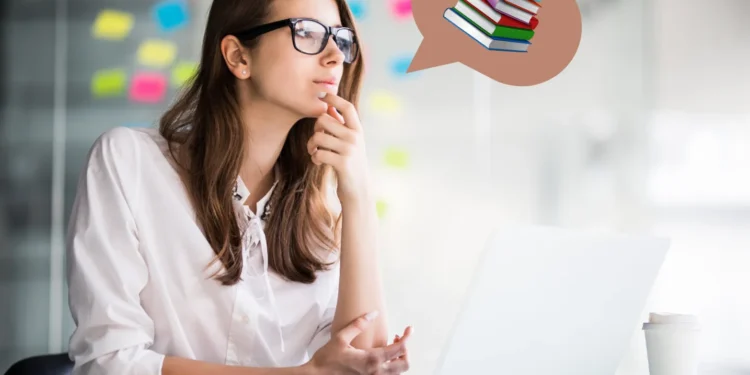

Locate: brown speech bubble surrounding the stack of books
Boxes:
[407,0,581,86]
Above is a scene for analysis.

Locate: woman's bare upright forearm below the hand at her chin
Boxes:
[332,197,388,349]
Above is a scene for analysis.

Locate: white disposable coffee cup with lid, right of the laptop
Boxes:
[643,313,700,375]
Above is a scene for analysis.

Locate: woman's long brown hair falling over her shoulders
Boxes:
[159,0,364,285]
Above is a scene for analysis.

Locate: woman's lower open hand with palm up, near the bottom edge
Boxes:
[304,315,411,375]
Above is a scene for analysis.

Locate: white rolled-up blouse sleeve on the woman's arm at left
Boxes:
[66,128,164,375]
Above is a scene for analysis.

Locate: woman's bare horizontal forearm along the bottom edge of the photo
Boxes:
[161,356,311,375]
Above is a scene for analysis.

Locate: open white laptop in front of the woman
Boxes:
[436,227,670,375]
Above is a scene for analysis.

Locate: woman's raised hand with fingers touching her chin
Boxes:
[307,94,370,205]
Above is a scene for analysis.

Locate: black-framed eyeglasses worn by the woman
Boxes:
[233,18,359,64]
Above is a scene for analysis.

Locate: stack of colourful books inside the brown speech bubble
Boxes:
[443,0,542,52]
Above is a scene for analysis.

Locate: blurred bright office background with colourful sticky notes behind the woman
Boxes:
[0,0,750,375]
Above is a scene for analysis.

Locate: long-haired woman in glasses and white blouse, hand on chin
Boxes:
[68,0,418,375]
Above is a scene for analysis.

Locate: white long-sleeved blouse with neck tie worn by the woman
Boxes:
[67,127,339,375]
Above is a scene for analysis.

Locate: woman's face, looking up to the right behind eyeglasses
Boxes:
[248,0,352,117]
